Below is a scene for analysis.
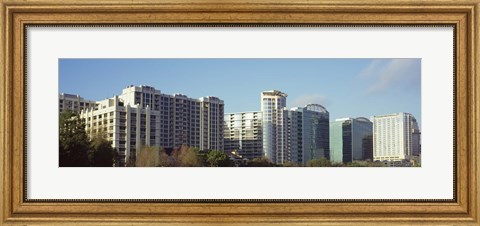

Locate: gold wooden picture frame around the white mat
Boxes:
[0,0,480,225]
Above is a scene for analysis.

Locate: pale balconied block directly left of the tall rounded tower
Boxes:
[224,111,264,159]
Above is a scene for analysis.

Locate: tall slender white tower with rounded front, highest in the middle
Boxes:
[261,90,288,164]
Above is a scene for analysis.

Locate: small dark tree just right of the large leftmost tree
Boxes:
[88,135,115,167]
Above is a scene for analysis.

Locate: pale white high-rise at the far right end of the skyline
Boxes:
[373,112,420,162]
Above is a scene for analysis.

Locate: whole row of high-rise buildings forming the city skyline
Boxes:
[59,86,421,166]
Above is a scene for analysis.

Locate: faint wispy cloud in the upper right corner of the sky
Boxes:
[358,59,421,94]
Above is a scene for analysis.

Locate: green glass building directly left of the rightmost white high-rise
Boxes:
[330,117,373,163]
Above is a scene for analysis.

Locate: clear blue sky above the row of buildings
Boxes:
[59,58,421,127]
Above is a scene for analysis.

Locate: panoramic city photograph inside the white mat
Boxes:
[58,58,421,167]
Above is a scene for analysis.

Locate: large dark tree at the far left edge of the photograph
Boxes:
[59,111,90,167]
